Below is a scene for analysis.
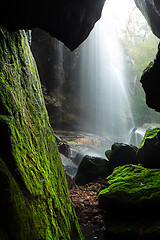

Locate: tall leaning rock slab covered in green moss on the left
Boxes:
[0,28,83,240]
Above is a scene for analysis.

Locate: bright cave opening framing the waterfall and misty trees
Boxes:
[31,0,160,161]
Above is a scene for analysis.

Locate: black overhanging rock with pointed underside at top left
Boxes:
[0,0,105,50]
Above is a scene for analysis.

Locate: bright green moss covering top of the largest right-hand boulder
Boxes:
[99,165,160,204]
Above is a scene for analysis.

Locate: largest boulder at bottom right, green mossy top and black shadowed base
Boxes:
[98,165,160,240]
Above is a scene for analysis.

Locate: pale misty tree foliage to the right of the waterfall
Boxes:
[122,7,160,125]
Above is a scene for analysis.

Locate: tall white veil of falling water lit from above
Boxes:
[80,0,134,142]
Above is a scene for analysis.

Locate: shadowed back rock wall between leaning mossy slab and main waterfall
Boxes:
[31,28,81,130]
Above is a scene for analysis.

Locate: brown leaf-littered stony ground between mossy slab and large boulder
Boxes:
[70,179,107,240]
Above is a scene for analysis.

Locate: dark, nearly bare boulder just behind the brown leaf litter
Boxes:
[74,155,108,185]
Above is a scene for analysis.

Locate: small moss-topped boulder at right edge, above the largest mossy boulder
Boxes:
[137,128,160,168]
